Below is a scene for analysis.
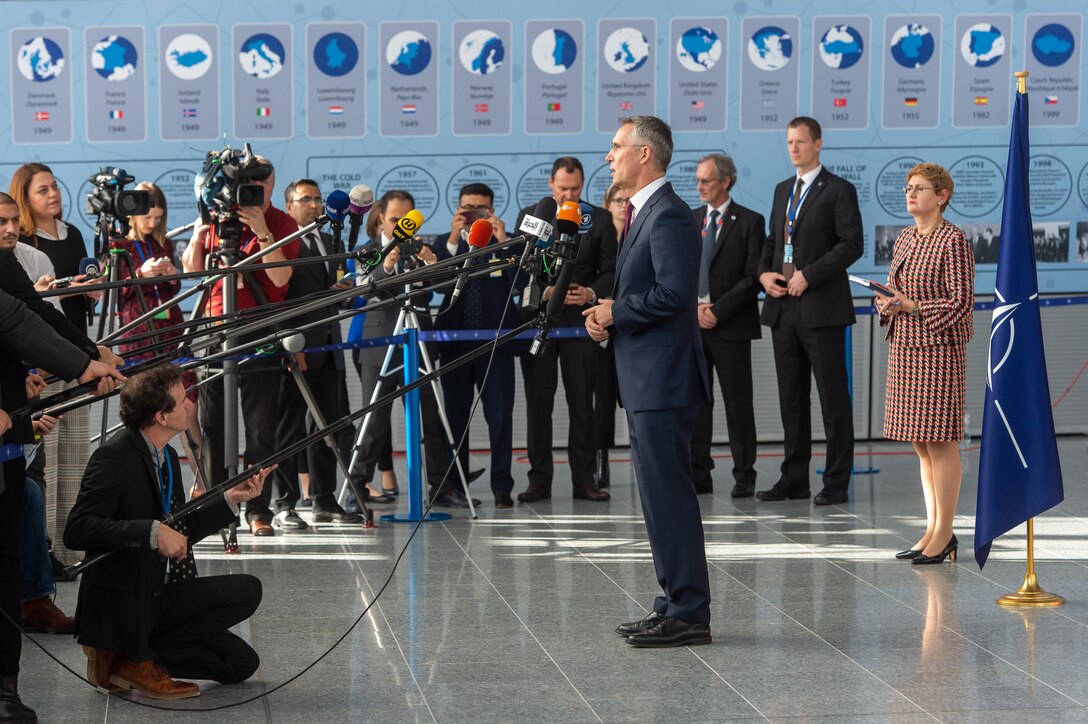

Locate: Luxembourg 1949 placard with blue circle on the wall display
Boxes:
[306,23,367,138]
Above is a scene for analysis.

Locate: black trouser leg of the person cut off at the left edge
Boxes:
[0,457,25,676]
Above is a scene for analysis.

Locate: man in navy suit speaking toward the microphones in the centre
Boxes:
[583,115,710,648]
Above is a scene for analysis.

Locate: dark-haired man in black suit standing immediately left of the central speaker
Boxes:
[517,156,616,503]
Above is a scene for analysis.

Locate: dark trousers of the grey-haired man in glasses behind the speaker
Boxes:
[691,331,756,488]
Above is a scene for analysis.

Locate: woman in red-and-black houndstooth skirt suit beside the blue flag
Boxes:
[876,163,975,564]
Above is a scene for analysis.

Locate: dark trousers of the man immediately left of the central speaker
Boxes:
[521,340,598,489]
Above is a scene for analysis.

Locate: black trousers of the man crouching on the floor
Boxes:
[148,574,261,684]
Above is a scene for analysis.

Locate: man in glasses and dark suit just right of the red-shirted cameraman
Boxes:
[272,179,362,522]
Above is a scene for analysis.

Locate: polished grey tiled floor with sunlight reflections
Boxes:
[21,438,1088,724]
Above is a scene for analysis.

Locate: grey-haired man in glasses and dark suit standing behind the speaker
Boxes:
[691,154,767,498]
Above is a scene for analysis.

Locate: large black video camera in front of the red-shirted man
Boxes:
[194,144,272,251]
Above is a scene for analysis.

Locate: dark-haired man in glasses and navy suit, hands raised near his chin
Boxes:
[434,184,524,508]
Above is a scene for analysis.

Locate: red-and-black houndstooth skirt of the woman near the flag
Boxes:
[883,342,967,442]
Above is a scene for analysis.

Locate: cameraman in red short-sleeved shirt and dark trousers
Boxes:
[182,157,300,536]
